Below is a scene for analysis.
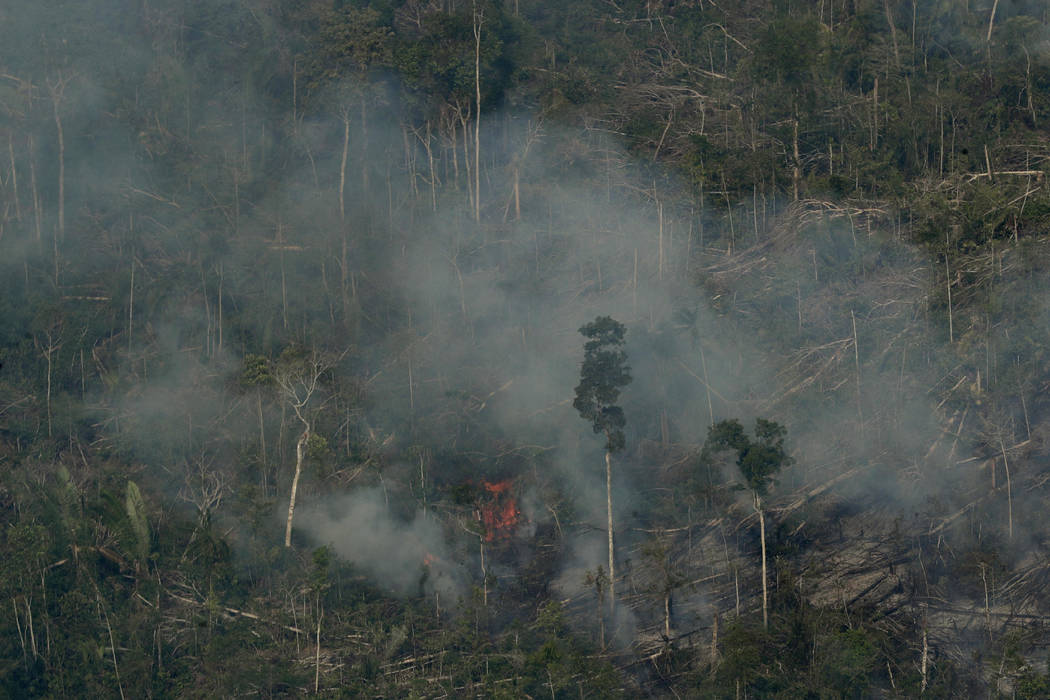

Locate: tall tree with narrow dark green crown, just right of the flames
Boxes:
[572,316,631,611]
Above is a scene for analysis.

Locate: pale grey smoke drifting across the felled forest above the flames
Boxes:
[0,3,1048,634]
